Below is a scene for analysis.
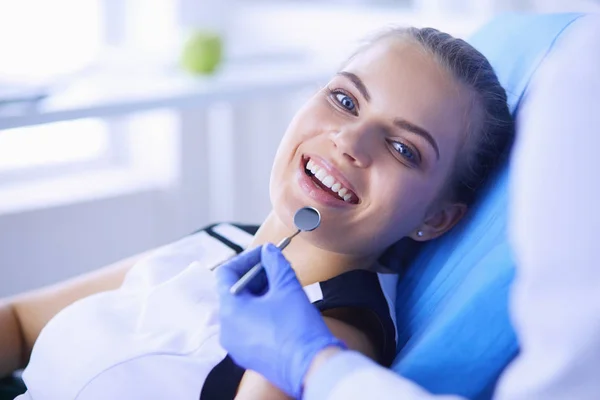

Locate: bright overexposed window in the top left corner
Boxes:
[0,0,102,82]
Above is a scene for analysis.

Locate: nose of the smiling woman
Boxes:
[331,124,376,168]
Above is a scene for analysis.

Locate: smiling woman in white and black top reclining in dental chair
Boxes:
[5,29,512,399]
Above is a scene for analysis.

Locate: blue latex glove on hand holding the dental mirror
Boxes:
[216,244,345,398]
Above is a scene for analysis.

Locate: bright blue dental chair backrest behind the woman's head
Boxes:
[392,14,580,399]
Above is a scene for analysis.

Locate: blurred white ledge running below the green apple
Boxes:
[0,54,327,130]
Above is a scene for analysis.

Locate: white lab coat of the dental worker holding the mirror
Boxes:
[304,15,600,400]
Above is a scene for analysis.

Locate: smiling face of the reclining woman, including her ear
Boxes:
[270,40,472,256]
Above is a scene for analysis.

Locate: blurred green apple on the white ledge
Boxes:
[180,30,223,74]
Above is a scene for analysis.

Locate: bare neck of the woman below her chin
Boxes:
[251,212,377,286]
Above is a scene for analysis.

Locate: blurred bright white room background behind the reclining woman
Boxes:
[0,0,600,297]
